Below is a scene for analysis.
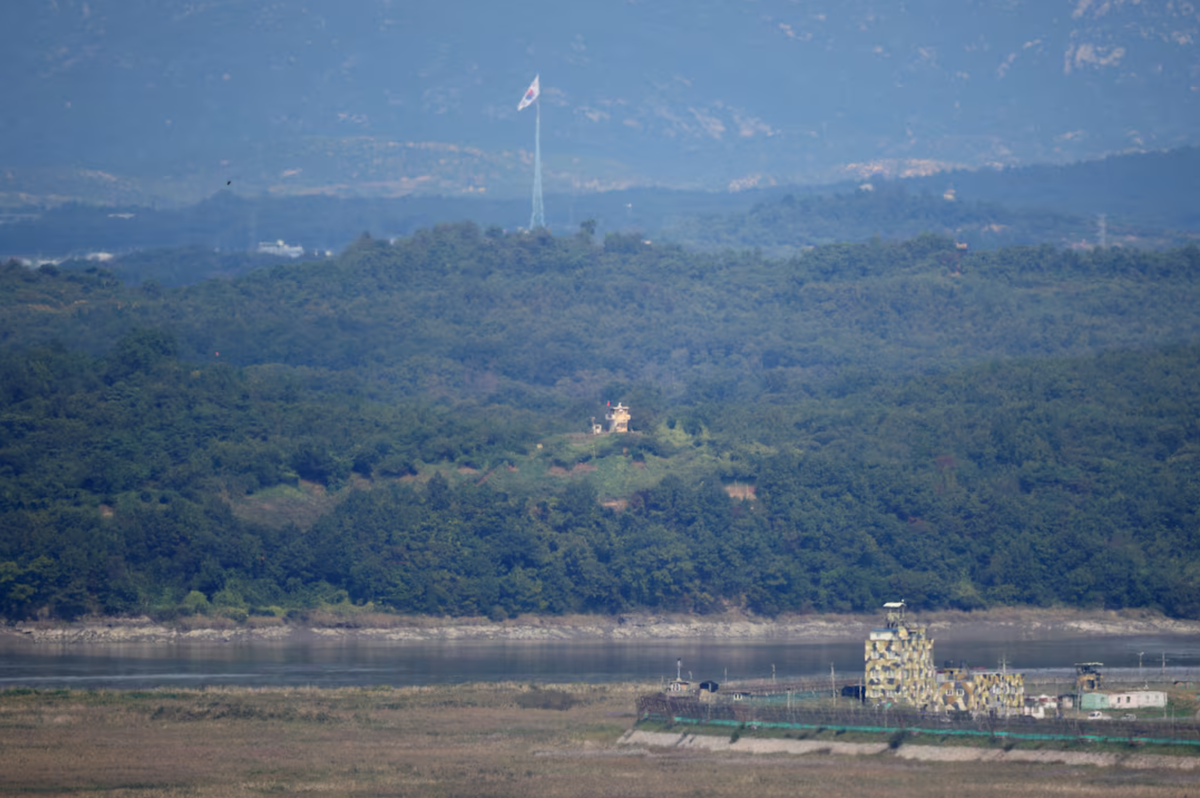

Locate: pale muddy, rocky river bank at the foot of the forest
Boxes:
[0,608,1200,644]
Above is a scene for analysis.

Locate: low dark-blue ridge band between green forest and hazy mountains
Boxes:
[7,148,1200,264]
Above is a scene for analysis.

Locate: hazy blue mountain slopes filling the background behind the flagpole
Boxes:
[0,0,1200,205]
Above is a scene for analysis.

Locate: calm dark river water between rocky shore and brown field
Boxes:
[0,636,1200,688]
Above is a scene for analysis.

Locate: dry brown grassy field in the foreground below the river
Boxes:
[0,684,1200,798]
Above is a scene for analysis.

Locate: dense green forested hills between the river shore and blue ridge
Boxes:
[0,224,1200,619]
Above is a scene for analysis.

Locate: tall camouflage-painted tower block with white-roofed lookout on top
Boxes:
[864,601,937,708]
